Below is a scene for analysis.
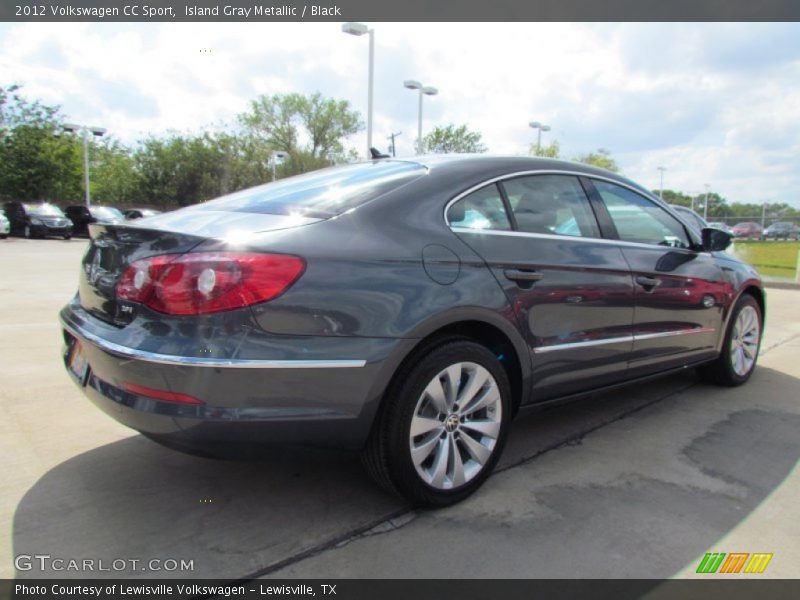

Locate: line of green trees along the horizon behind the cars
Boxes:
[0,85,800,219]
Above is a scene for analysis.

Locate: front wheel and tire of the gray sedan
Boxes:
[698,294,764,387]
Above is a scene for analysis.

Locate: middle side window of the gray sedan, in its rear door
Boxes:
[502,175,600,237]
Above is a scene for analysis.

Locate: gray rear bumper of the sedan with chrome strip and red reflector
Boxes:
[61,301,408,451]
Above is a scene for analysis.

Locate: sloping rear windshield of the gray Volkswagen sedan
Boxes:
[195,161,426,219]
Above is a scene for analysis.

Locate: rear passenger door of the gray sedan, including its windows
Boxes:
[448,174,634,401]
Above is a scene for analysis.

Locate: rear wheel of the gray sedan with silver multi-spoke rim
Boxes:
[362,339,512,507]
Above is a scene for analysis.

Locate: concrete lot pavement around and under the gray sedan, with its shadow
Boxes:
[0,238,800,578]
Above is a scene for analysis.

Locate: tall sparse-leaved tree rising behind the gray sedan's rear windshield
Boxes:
[239,93,363,175]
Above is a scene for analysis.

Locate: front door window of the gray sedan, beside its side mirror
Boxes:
[593,180,691,248]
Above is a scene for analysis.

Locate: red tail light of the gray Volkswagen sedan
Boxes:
[117,252,305,315]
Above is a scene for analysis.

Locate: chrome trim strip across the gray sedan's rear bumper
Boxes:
[61,318,367,369]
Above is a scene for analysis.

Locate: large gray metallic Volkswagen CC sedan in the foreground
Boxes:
[60,156,764,506]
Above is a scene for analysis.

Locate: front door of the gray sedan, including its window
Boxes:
[587,179,732,377]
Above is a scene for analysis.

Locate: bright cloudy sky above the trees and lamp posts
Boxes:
[0,23,800,207]
